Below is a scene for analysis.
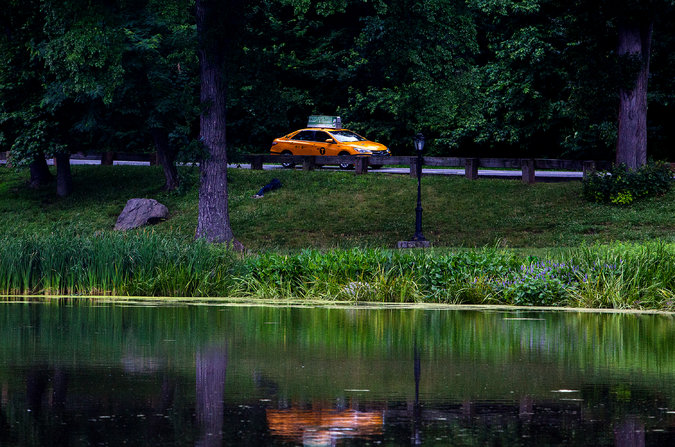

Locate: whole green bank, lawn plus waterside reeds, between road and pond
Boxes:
[0,166,675,310]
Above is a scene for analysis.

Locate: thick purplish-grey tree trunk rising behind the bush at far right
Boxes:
[616,21,653,169]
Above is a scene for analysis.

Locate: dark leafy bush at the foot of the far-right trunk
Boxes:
[583,162,673,206]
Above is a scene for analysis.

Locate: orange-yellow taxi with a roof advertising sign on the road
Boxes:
[270,117,391,169]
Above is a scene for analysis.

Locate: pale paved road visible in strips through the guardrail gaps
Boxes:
[0,158,583,181]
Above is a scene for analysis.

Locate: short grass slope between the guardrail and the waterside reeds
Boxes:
[0,166,675,250]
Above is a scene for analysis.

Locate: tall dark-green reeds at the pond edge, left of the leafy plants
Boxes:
[0,232,238,296]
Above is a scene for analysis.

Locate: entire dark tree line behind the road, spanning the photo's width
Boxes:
[0,0,675,193]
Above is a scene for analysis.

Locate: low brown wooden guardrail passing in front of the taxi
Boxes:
[246,154,611,183]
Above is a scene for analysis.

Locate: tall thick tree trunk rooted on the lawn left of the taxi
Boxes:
[195,0,243,249]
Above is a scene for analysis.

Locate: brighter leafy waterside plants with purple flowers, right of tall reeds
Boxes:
[235,243,675,310]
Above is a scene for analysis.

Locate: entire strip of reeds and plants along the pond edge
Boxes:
[0,232,675,310]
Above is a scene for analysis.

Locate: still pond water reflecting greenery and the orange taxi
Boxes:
[0,300,675,446]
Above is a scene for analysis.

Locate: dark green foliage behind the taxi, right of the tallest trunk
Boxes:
[230,0,675,159]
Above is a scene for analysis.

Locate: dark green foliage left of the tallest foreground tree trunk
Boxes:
[0,0,198,165]
